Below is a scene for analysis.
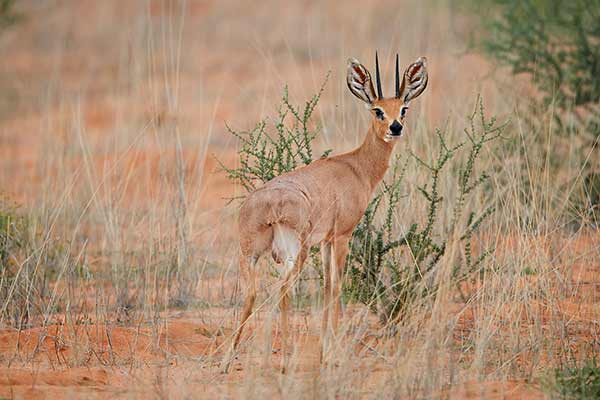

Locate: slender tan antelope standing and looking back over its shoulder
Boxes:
[222,53,428,372]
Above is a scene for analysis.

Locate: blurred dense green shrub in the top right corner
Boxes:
[481,0,600,109]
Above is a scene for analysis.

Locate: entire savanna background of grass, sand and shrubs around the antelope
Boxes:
[0,0,600,398]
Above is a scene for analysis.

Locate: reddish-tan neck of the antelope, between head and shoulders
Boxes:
[354,125,394,190]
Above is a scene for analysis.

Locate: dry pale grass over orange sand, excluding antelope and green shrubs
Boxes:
[0,0,600,398]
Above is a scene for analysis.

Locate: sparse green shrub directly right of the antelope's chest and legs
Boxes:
[346,102,504,323]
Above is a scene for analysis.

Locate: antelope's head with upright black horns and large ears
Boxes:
[347,53,427,142]
